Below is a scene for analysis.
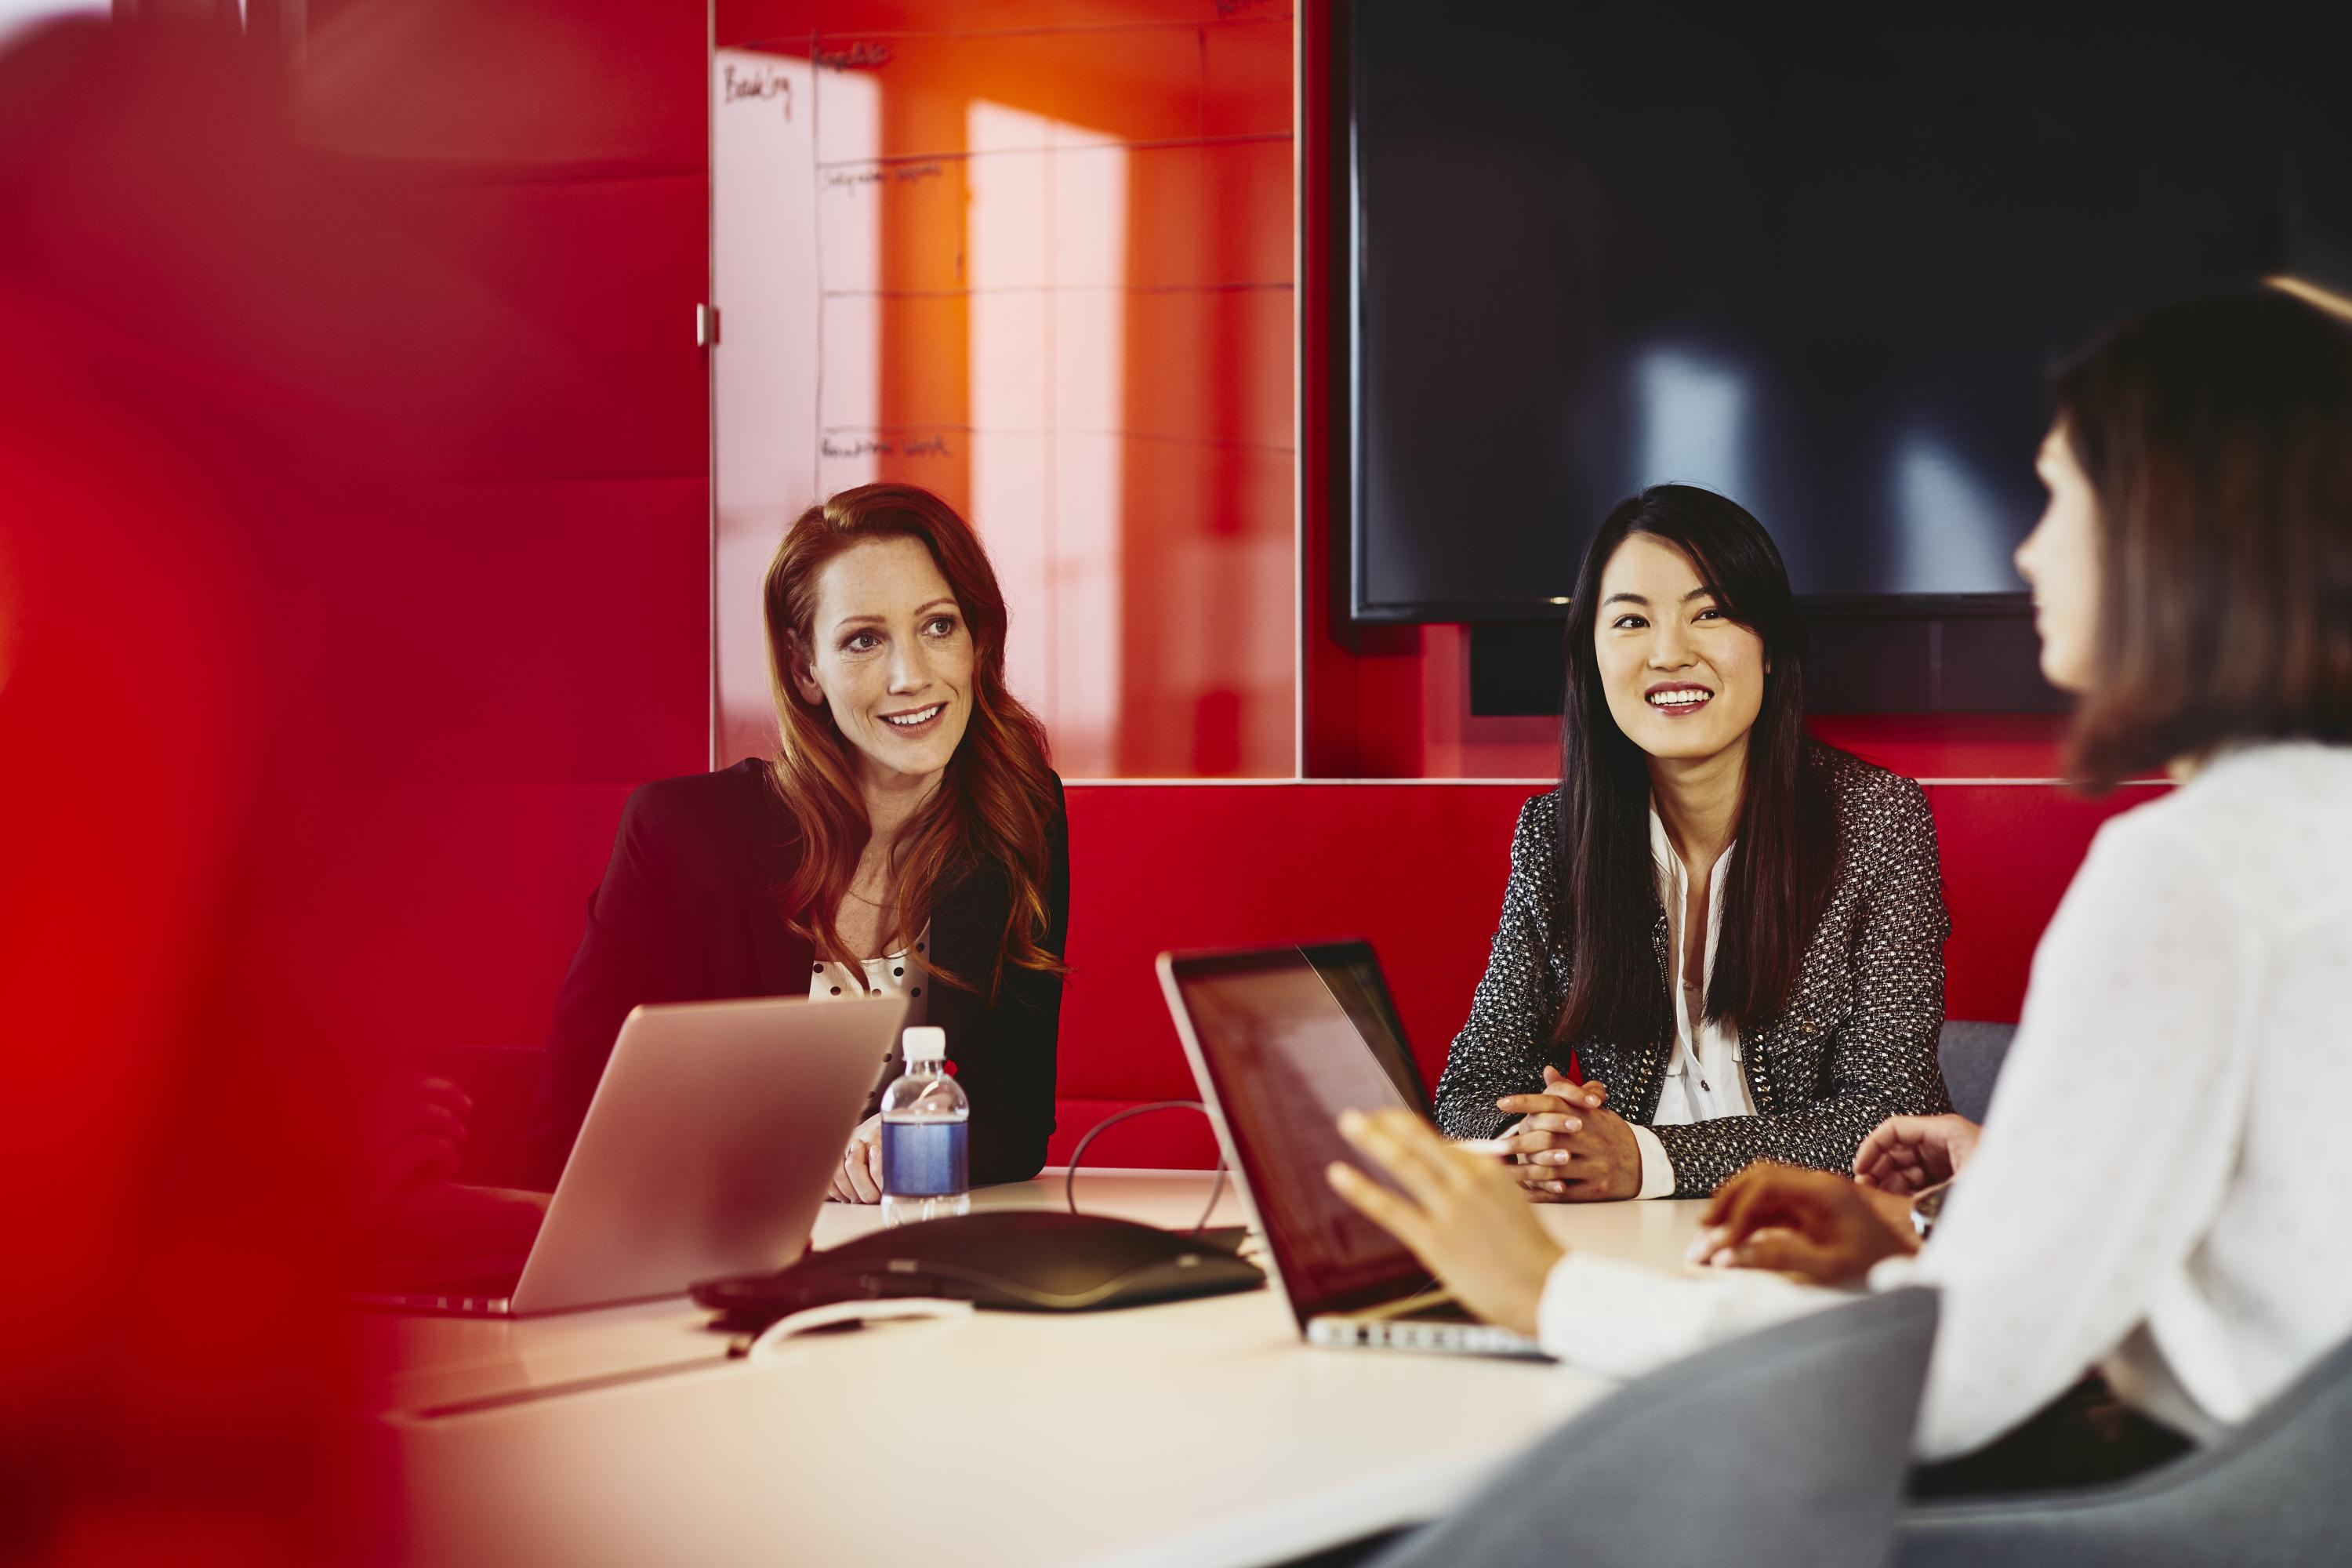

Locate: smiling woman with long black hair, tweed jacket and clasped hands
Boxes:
[1437,485,1950,1201]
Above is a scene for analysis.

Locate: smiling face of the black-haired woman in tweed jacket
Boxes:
[1592,534,1771,762]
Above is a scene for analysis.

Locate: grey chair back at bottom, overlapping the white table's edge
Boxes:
[1374,1290,1936,1568]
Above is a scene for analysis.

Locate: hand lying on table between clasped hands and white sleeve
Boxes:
[1691,1161,1919,1286]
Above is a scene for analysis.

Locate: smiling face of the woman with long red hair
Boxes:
[793,539,976,785]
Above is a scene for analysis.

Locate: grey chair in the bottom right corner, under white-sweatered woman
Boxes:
[1896,1342,2352,1568]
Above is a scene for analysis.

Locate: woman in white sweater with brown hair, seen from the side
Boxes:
[1331,294,2352,1486]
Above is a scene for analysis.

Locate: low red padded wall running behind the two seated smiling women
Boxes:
[433,766,2157,1166]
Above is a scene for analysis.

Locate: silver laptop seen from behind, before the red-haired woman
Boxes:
[360,996,906,1316]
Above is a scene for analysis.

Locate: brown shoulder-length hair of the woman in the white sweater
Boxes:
[2053,289,2352,789]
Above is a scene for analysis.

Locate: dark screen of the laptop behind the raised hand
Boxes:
[1169,947,1430,1323]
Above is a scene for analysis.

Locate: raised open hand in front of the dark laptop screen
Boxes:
[1324,1109,1562,1335]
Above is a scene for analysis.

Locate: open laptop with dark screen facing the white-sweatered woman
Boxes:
[1160,942,1550,1359]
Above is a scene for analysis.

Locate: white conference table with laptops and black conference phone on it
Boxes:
[367,1171,1700,1568]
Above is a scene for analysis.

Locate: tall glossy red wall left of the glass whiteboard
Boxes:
[301,0,710,1081]
